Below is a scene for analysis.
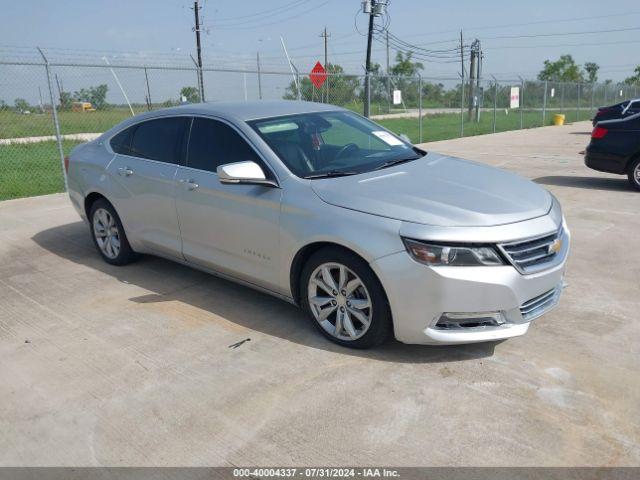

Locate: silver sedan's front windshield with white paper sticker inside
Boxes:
[249,112,424,178]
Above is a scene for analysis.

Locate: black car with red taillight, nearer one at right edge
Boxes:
[584,113,640,190]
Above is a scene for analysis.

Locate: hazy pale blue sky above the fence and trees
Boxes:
[0,0,640,105]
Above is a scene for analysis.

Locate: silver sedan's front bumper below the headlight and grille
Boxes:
[371,223,570,345]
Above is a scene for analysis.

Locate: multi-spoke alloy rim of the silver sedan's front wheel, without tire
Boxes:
[307,263,373,341]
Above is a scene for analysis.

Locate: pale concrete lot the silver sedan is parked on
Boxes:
[0,122,640,466]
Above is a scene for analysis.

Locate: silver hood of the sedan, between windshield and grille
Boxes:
[311,152,552,226]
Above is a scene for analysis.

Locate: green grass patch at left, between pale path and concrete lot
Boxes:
[0,140,79,200]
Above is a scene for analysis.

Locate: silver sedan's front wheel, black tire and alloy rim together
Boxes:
[299,247,393,349]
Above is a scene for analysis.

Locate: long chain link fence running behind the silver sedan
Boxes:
[0,57,639,200]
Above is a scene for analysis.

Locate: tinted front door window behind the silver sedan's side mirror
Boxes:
[187,117,262,172]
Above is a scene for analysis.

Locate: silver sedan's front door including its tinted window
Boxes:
[176,117,281,289]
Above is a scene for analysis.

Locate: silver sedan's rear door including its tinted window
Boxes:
[107,117,190,258]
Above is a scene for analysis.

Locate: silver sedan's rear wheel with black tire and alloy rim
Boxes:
[89,198,137,266]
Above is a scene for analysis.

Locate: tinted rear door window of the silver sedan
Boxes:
[129,117,188,164]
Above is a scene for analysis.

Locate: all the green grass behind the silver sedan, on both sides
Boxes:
[0,108,591,200]
